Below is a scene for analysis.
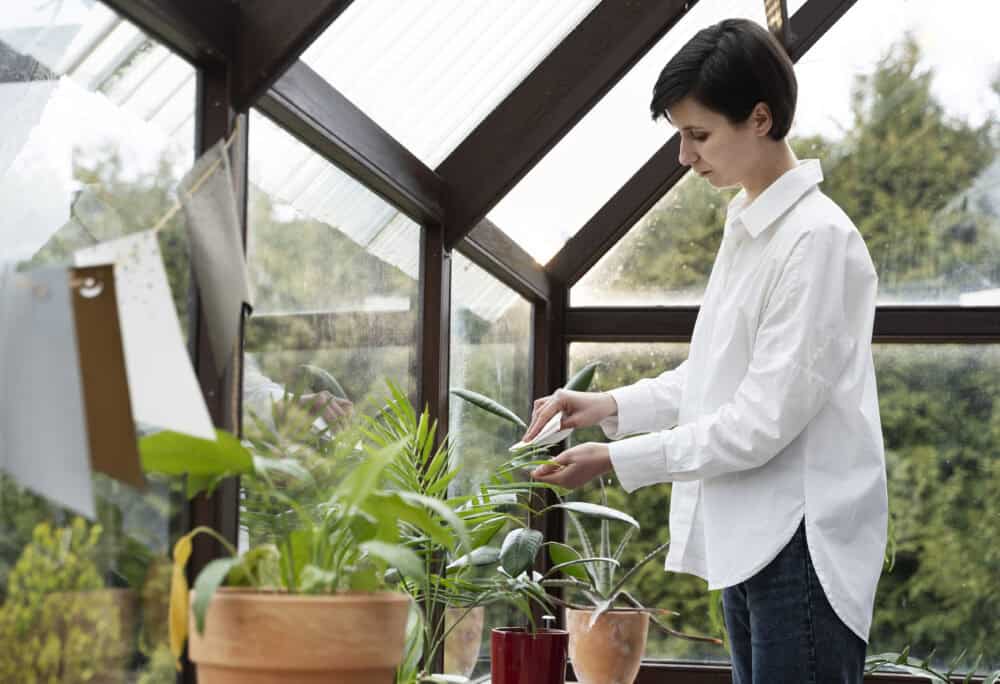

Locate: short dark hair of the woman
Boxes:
[650,19,798,140]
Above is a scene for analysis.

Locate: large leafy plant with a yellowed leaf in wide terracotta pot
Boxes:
[140,396,468,684]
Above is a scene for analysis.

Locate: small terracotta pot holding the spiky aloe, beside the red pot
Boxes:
[566,610,649,684]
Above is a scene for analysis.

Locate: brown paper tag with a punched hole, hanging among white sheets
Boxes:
[70,265,146,489]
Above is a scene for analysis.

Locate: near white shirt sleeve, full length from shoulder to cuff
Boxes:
[609,227,876,491]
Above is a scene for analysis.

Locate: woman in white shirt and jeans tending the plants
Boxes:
[524,19,887,684]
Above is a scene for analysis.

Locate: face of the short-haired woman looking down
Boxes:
[667,97,770,188]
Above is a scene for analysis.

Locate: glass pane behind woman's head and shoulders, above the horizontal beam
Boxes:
[576,0,1000,306]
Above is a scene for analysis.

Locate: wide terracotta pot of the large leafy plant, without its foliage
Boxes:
[188,589,410,684]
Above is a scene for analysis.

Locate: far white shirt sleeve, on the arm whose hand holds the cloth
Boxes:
[600,361,687,439]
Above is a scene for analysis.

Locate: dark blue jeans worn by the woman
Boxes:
[722,522,867,684]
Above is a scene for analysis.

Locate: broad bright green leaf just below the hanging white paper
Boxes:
[139,430,253,482]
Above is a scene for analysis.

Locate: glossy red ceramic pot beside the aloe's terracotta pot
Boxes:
[490,627,569,684]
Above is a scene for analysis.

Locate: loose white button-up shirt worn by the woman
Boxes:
[602,160,888,642]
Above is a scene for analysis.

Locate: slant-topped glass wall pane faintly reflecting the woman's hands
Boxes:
[241,113,420,547]
